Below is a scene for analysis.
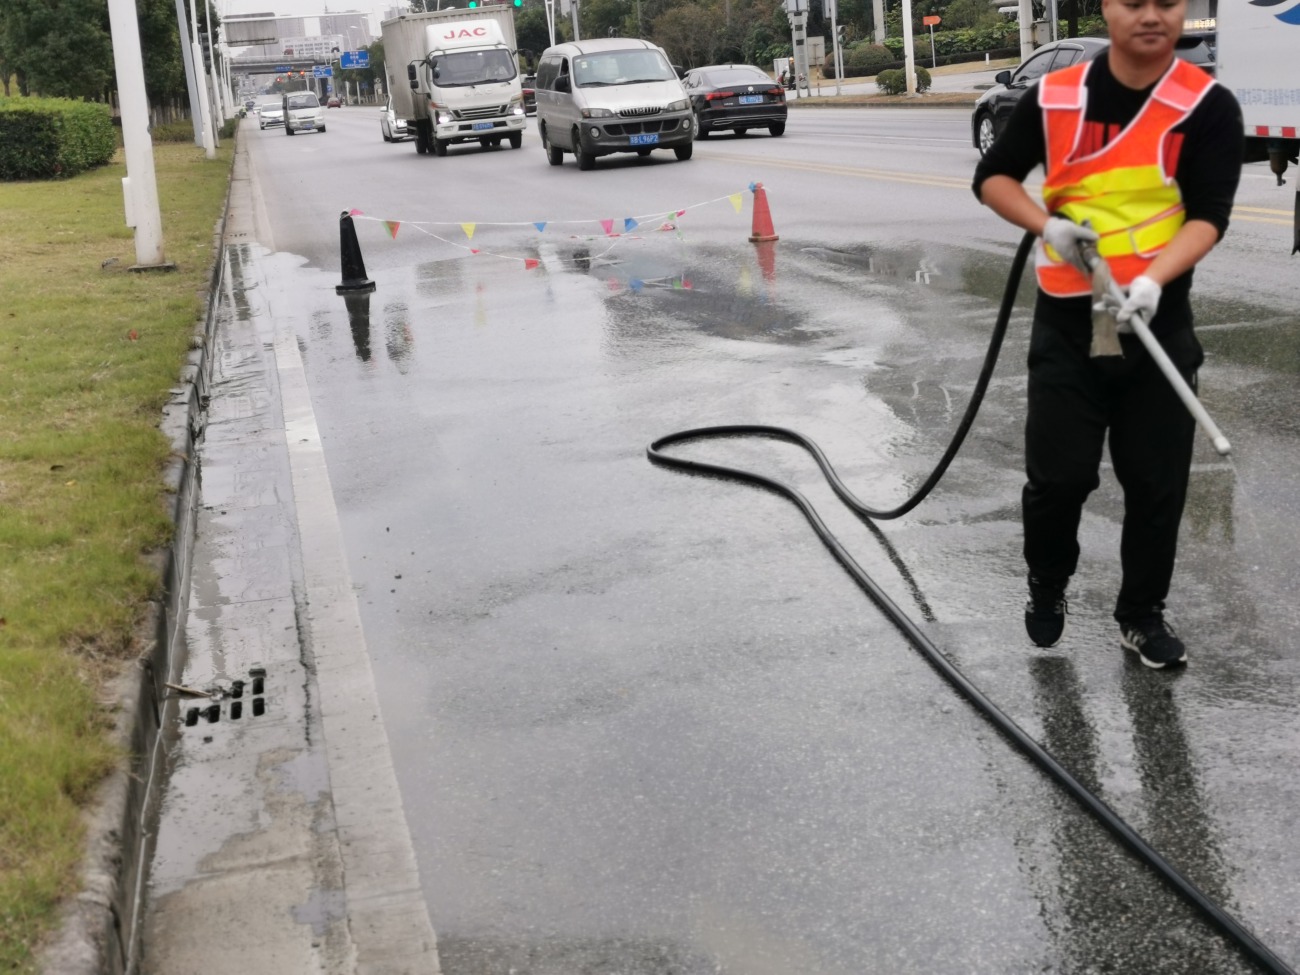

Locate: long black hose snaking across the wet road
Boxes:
[646,234,1296,975]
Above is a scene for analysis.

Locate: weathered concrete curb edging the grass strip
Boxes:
[36,137,238,975]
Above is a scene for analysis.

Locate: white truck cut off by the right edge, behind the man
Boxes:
[1214,0,1300,254]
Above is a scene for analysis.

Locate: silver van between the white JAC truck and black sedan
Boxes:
[536,38,696,169]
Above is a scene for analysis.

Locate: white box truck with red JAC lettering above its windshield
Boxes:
[380,7,524,156]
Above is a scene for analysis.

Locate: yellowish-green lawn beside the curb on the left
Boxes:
[0,135,231,972]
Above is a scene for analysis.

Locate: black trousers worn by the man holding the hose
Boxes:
[1023,315,1203,623]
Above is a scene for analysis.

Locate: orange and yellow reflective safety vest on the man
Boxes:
[1035,59,1214,298]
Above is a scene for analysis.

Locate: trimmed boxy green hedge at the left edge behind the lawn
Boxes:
[0,98,117,179]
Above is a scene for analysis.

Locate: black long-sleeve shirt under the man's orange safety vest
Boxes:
[972,52,1245,334]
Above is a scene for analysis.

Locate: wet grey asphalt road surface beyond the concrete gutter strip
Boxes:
[239,109,1300,975]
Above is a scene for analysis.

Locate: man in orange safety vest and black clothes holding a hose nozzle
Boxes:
[974,0,1243,667]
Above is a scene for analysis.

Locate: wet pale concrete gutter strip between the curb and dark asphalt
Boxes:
[136,137,438,975]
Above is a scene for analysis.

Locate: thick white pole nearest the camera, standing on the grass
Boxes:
[108,0,166,268]
